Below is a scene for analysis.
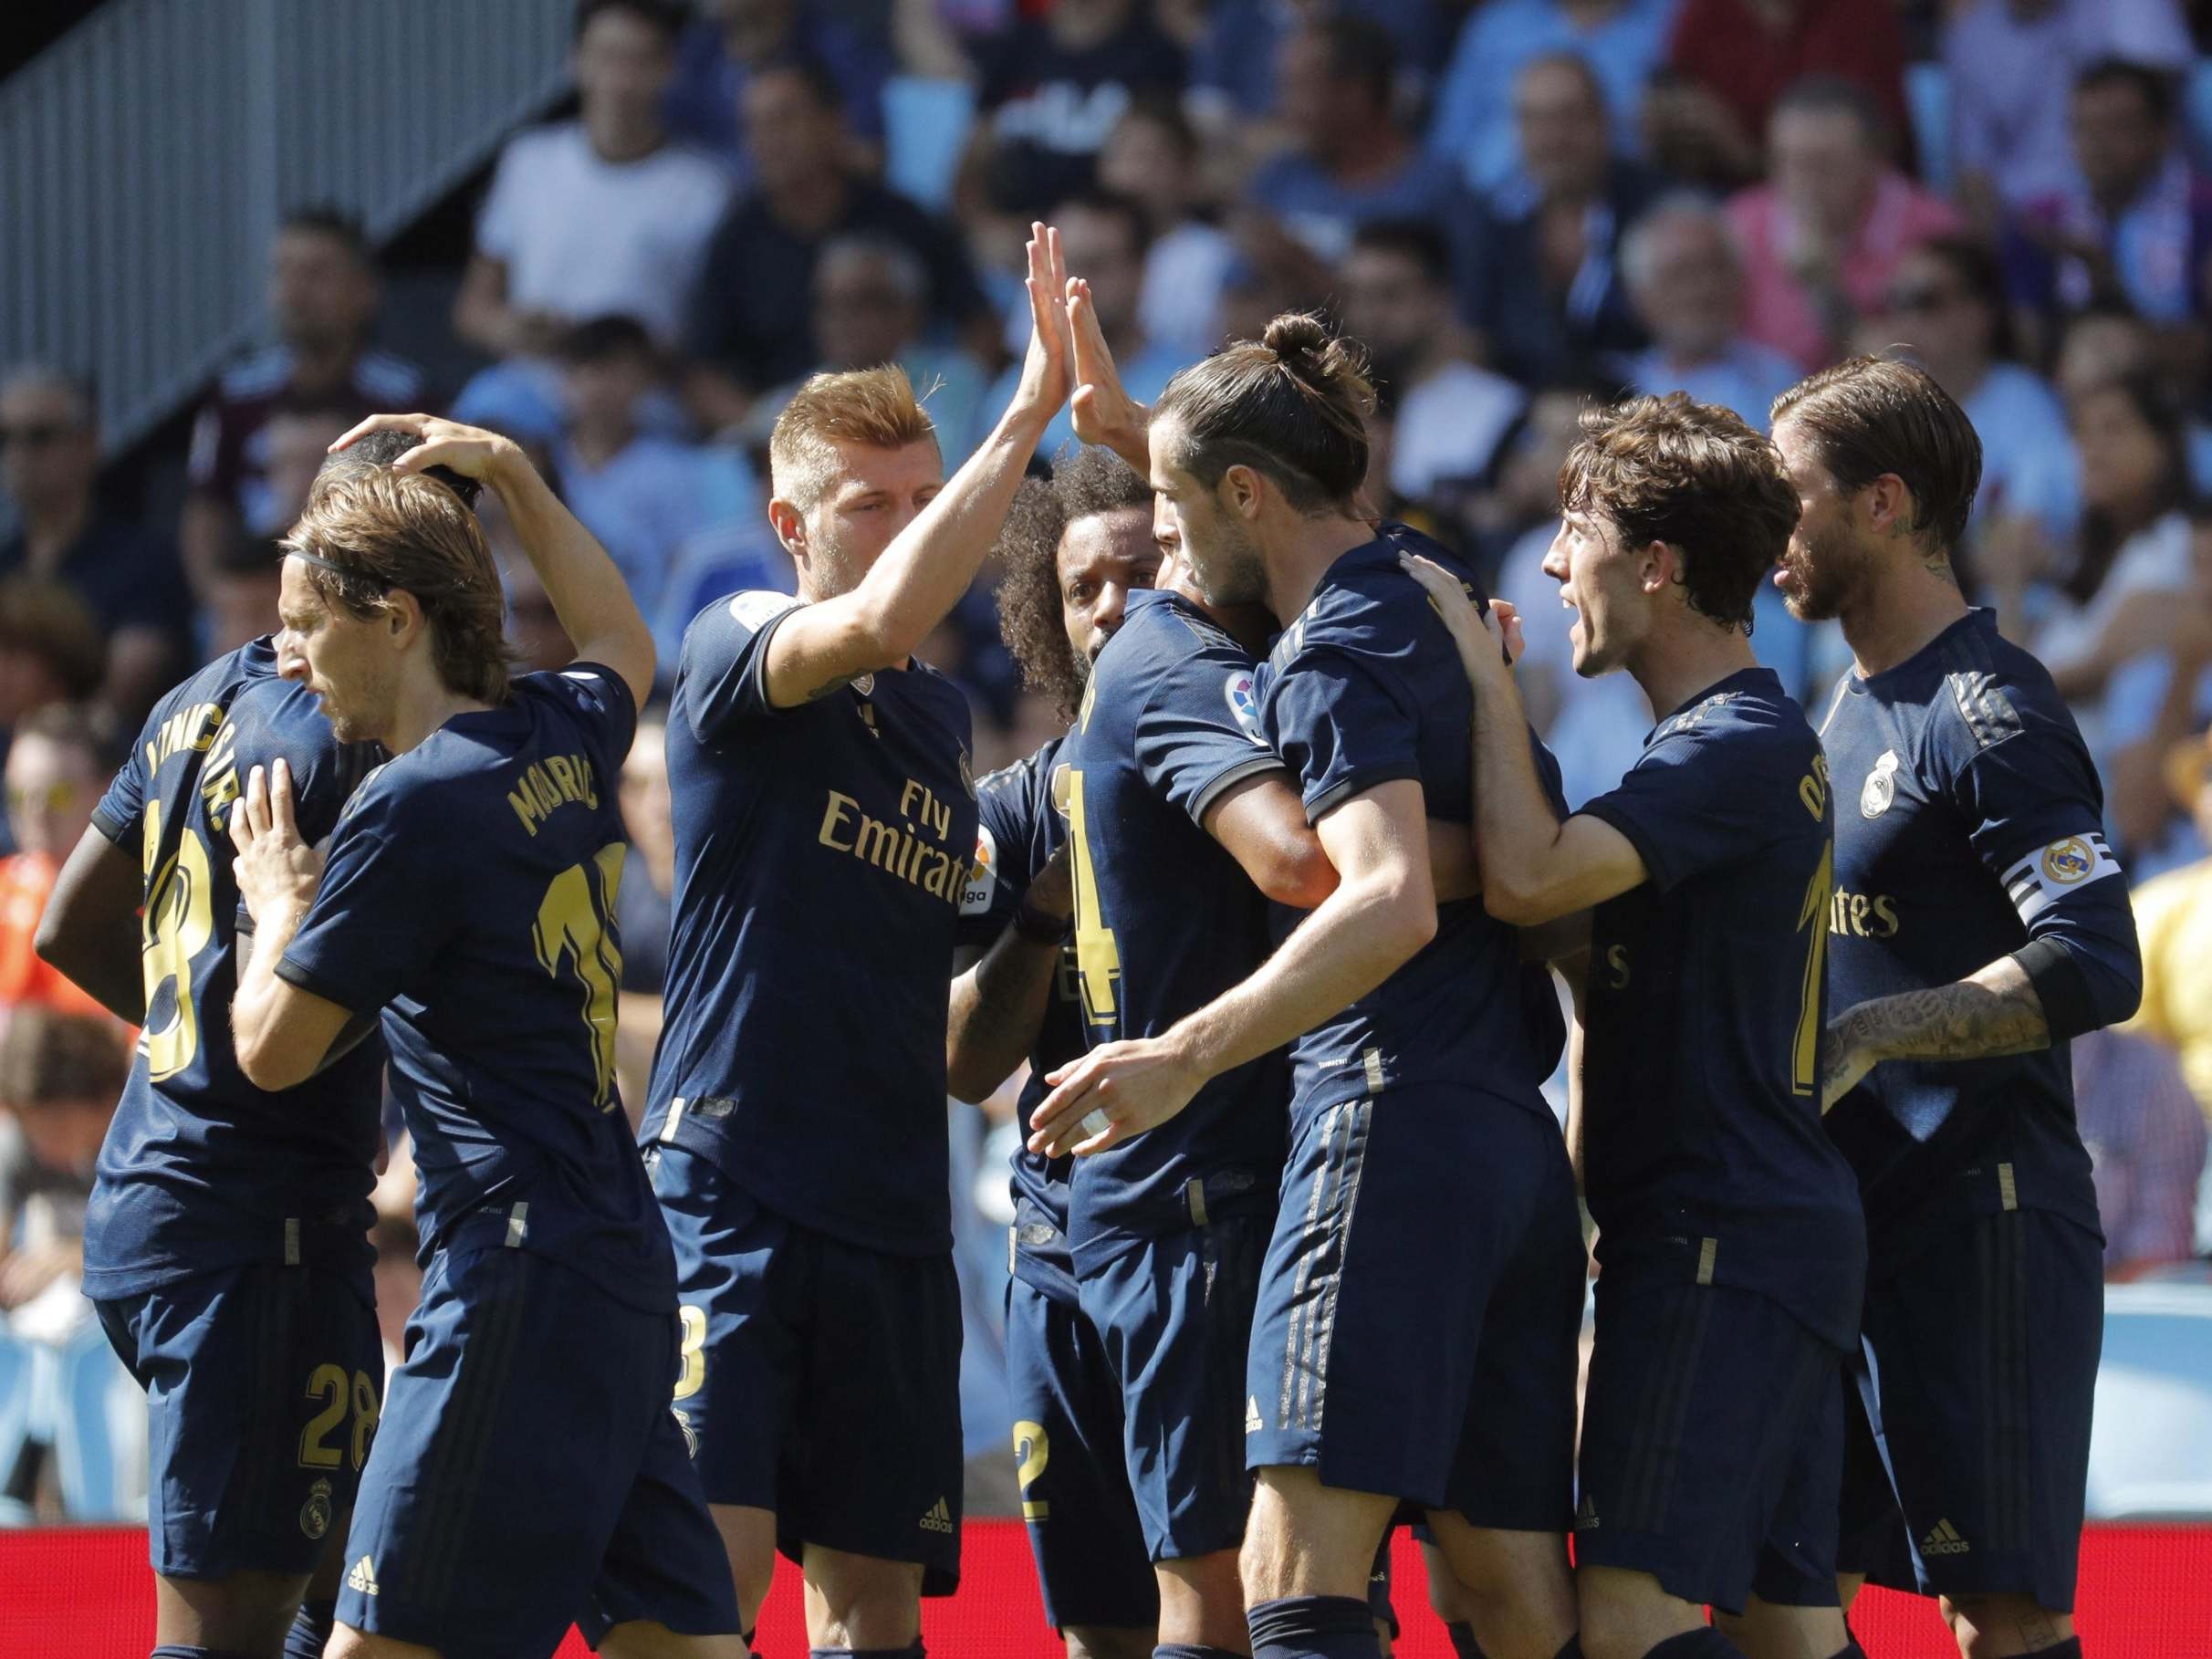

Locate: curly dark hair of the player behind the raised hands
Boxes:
[997,447,1153,721]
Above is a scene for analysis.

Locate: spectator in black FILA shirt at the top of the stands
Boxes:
[976,0,1184,217]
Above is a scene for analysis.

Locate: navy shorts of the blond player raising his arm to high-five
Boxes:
[648,1146,965,1595]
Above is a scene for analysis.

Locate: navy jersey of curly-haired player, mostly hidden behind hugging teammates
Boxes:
[960,736,1086,1299]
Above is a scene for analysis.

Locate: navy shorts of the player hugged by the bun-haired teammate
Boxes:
[1077,1210,1274,1561]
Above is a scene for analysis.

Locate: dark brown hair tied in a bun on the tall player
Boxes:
[1153,312,1376,516]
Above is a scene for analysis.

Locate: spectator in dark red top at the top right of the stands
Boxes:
[1643,0,1909,183]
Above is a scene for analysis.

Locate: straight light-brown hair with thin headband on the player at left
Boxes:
[278,464,513,704]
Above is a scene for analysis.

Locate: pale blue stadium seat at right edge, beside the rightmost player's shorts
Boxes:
[2088,1283,2212,1522]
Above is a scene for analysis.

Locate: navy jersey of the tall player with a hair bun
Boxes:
[1258,522,1566,1115]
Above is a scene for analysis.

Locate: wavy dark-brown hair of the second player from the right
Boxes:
[1560,391,1799,632]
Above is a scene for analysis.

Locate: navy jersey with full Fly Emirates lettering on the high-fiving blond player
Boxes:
[643,593,976,1254]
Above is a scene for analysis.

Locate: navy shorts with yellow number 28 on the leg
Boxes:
[95,1266,385,1580]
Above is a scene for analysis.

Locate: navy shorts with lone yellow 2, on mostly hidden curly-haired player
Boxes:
[1007,1272,1159,1630]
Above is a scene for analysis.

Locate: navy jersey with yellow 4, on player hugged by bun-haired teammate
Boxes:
[1064,590,1289,1261]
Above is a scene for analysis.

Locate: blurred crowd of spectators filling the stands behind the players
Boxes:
[13,0,2212,1507]
